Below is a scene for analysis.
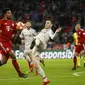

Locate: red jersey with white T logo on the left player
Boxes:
[0,19,17,41]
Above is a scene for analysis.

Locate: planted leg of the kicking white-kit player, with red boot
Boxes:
[32,39,50,85]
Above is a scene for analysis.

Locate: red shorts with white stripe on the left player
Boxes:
[0,41,12,54]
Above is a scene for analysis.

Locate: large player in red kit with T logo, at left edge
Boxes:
[0,8,27,78]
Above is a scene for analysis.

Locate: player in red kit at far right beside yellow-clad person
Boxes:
[72,23,84,70]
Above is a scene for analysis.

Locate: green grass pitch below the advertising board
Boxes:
[0,59,85,85]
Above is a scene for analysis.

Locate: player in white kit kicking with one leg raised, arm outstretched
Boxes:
[32,20,61,85]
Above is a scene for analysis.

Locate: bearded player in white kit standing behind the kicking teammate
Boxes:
[19,21,37,72]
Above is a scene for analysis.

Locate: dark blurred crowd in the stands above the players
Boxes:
[0,0,85,47]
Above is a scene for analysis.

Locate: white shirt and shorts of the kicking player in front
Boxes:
[32,28,57,57]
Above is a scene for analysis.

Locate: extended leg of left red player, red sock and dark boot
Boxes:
[9,51,27,78]
